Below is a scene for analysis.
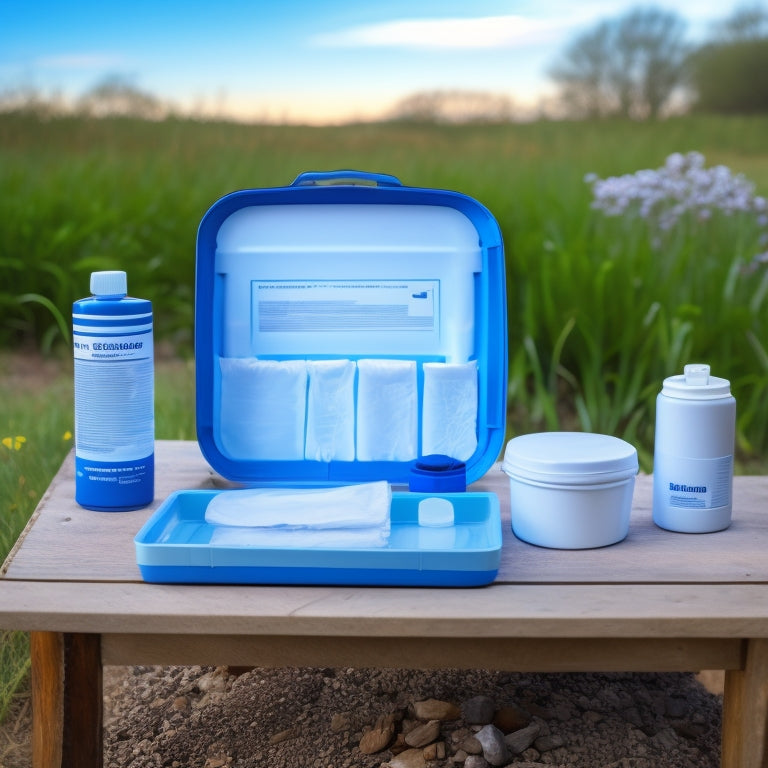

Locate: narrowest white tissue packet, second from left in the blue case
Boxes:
[304,360,357,461]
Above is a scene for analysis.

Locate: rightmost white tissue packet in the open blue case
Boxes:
[421,361,478,461]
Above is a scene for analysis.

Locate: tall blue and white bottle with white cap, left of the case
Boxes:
[72,271,155,512]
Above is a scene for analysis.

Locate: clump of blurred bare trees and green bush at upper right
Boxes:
[549,6,768,119]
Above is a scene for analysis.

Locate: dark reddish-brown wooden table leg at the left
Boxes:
[30,632,104,768]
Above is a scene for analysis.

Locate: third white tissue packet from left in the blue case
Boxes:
[357,359,419,461]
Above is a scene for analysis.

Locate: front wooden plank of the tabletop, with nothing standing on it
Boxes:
[0,581,768,638]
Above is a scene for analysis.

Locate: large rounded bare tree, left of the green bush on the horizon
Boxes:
[549,7,688,119]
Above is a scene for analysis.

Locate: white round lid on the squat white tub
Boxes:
[501,432,638,485]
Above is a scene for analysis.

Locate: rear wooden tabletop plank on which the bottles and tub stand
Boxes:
[5,440,768,584]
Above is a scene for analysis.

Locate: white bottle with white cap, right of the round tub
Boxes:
[653,364,736,533]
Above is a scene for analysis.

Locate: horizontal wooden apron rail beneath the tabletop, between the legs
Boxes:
[102,634,744,672]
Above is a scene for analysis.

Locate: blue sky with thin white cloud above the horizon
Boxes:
[0,0,752,123]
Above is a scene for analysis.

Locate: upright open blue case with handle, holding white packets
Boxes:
[195,171,507,486]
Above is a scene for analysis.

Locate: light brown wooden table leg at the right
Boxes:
[722,639,768,768]
